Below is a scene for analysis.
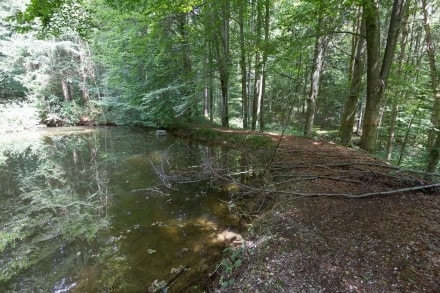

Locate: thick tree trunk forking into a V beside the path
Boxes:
[361,0,404,153]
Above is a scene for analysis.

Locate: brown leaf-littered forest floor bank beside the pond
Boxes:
[176,130,440,292]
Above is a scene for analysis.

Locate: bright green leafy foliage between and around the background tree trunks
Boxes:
[0,0,440,169]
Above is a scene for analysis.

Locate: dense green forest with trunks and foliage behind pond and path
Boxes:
[0,0,440,173]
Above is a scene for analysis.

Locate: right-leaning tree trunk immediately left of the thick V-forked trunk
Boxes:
[339,12,366,145]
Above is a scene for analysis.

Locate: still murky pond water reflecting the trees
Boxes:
[0,127,239,292]
